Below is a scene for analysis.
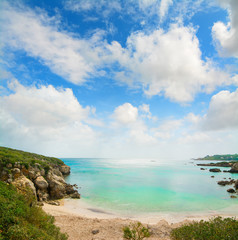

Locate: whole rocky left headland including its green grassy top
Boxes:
[0,147,80,204]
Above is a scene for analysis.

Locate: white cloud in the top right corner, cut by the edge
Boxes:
[212,0,238,58]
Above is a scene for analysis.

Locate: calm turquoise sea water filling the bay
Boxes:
[62,158,238,213]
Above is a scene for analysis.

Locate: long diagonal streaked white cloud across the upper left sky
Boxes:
[1,2,107,84]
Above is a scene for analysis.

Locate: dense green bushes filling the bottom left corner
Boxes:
[0,181,67,240]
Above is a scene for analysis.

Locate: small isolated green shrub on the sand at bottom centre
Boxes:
[123,222,151,240]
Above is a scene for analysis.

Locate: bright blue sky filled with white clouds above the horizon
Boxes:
[0,0,238,160]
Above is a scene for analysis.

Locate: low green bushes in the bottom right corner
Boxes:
[171,217,238,240]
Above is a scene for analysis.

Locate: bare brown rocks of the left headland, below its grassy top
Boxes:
[0,147,80,205]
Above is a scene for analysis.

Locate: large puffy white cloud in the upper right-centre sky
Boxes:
[108,25,231,103]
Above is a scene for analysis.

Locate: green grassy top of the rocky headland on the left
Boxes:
[0,147,64,169]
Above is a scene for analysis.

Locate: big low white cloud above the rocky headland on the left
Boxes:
[0,80,97,156]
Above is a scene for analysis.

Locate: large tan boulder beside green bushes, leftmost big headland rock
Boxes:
[12,175,36,200]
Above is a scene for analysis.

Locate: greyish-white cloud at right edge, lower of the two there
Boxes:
[201,89,238,130]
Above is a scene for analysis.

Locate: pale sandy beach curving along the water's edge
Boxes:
[43,199,238,240]
